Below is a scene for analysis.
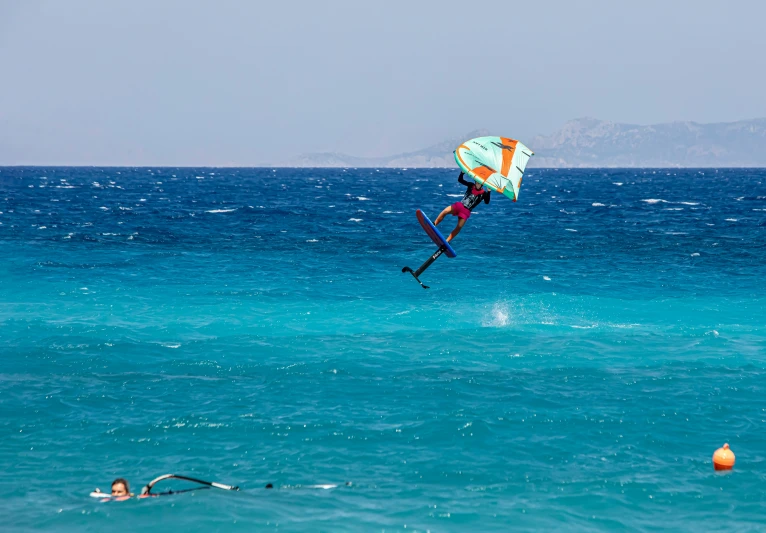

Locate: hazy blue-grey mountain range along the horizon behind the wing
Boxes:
[285,118,766,168]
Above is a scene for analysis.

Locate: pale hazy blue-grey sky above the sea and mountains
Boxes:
[0,0,766,165]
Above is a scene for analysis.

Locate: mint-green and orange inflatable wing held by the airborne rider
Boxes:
[455,137,535,202]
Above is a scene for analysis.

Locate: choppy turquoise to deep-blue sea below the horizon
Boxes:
[0,168,766,531]
